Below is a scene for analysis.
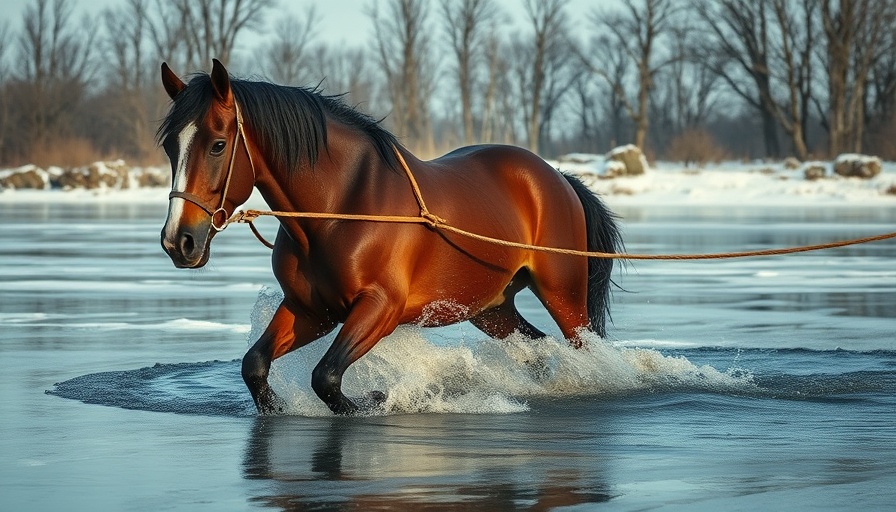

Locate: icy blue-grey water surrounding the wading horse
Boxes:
[0,199,896,511]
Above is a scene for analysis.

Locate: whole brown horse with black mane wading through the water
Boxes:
[158,60,621,414]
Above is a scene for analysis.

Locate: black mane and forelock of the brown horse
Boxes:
[156,74,398,171]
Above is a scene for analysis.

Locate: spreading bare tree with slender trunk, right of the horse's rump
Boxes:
[585,0,681,152]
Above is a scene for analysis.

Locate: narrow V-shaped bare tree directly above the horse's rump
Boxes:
[441,0,500,144]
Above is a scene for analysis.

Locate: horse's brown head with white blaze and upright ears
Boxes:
[159,60,255,268]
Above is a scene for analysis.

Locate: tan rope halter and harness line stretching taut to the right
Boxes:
[206,102,896,260]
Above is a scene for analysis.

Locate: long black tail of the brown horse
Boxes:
[563,173,623,337]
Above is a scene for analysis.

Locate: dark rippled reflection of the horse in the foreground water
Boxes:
[244,415,613,511]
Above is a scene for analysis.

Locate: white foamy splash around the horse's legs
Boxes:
[250,289,755,416]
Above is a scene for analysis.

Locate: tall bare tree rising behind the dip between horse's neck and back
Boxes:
[370,0,435,152]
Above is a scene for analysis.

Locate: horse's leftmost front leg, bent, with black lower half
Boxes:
[242,302,336,414]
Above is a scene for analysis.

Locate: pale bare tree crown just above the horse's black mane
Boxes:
[264,4,320,85]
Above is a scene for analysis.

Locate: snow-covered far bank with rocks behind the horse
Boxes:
[0,154,896,207]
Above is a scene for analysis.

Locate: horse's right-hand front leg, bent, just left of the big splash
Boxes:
[311,292,398,415]
